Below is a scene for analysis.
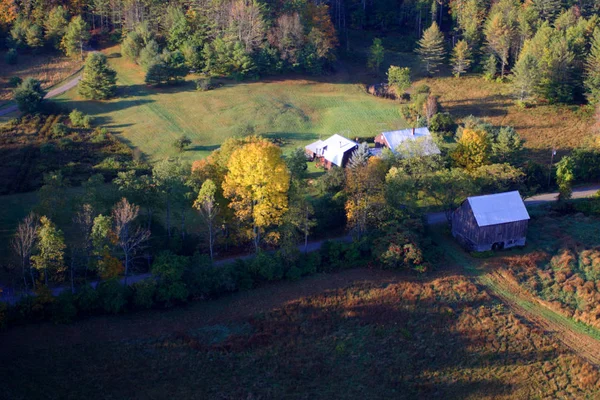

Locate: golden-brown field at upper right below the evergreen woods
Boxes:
[415,76,593,163]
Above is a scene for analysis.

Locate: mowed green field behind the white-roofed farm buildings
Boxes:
[57,47,407,160]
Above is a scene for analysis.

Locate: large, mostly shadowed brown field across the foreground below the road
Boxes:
[0,270,600,399]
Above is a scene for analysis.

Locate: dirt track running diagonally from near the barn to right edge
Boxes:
[435,227,600,367]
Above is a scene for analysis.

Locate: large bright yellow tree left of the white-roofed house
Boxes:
[223,140,290,251]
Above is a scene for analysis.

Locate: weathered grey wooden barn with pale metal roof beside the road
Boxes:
[452,191,529,251]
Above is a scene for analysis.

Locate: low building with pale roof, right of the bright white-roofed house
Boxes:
[375,127,440,157]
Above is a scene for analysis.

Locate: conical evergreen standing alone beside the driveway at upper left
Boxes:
[79,53,117,100]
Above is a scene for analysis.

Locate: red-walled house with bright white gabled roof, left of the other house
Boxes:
[304,134,358,169]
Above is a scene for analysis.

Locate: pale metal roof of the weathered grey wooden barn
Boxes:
[467,191,529,227]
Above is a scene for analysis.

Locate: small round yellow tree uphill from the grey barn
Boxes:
[452,129,491,171]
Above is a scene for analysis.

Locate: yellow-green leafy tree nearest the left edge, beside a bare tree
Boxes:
[31,216,66,286]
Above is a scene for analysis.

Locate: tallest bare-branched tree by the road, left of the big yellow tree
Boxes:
[112,198,150,284]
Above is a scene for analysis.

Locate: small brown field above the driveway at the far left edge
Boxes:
[0,52,81,107]
